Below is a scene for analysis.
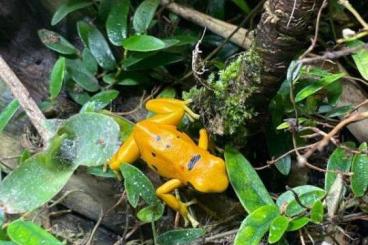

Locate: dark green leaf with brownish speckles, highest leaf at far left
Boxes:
[38,29,78,54]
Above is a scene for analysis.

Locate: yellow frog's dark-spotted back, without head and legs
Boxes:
[133,120,207,182]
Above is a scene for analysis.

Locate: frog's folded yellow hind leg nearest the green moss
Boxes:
[146,99,199,126]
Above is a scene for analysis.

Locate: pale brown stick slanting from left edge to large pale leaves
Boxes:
[0,55,51,145]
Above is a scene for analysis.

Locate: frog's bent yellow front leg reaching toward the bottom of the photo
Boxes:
[156,179,198,227]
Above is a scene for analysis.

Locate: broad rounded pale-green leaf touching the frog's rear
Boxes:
[59,112,120,166]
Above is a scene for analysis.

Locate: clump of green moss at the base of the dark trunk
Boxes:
[183,49,261,144]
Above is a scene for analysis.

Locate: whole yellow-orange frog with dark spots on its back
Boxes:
[109,99,229,225]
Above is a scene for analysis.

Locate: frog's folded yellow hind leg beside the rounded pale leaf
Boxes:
[109,135,139,170]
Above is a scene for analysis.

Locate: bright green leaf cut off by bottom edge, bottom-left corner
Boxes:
[7,220,63,245]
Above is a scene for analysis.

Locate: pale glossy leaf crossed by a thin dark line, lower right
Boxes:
[276,185,326,217]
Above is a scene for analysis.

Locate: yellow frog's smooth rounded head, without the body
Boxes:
[188,155,229,193]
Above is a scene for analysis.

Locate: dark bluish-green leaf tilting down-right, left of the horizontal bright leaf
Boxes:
[88,27,116,70]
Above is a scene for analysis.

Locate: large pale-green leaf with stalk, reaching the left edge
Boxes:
[0,135,77,214]
